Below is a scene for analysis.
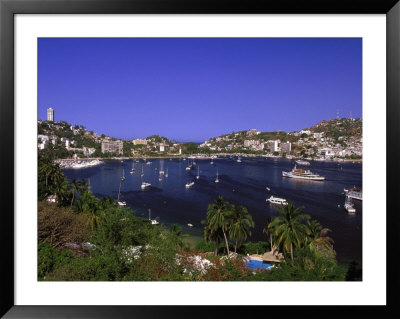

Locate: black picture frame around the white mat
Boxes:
[0,0,400,318]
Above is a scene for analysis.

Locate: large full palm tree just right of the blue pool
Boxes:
[268,202,310,260]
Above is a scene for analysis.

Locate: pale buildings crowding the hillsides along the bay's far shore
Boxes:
[38,108,362,159]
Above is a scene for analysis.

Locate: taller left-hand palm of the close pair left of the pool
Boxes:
[206,196,231,256]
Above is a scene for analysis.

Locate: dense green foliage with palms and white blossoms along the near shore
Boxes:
[38,152,354,281]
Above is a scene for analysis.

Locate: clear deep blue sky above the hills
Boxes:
[38,38,362,142]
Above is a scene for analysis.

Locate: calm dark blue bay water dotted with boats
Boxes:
[64,157,362,263]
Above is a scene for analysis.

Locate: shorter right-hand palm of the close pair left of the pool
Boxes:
[229,205,254,253]
